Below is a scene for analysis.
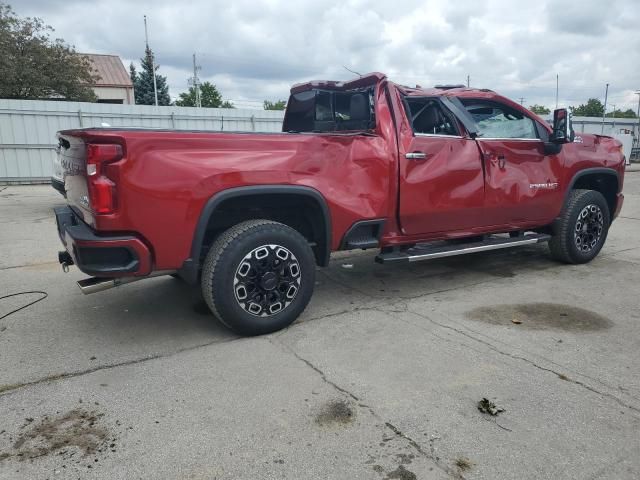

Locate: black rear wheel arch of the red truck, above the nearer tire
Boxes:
[179,185,331,283]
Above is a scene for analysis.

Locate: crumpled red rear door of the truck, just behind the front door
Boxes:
[399,97,484,235]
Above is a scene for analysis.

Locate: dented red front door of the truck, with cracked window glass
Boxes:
[462,99,562,225]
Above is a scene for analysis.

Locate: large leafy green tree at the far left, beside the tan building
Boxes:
[0,3,100,102]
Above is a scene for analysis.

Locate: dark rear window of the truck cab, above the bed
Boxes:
[282,88,375,132]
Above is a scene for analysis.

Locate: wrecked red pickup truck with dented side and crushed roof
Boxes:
[55,73,624,335]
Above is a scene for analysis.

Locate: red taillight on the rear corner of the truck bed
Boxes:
[87,143,122,215]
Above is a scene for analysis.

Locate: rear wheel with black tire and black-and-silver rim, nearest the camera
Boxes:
[201,220,316,335]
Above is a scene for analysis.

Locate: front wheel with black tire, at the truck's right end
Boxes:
[549,190,611,264]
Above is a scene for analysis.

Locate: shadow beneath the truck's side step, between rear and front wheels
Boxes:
[298,245,563,322]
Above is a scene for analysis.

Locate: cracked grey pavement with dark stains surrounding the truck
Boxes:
[0,171,640,480]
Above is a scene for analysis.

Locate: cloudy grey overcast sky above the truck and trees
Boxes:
[12,0,640,110]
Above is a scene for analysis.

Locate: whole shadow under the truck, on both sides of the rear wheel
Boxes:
[65,245,562,344]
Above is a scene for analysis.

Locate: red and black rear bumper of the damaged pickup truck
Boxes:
[54,207,151,277]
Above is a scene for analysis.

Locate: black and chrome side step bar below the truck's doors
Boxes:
[376,233,551,263]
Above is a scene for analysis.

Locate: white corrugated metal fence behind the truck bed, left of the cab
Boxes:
[0,99,283,183]
